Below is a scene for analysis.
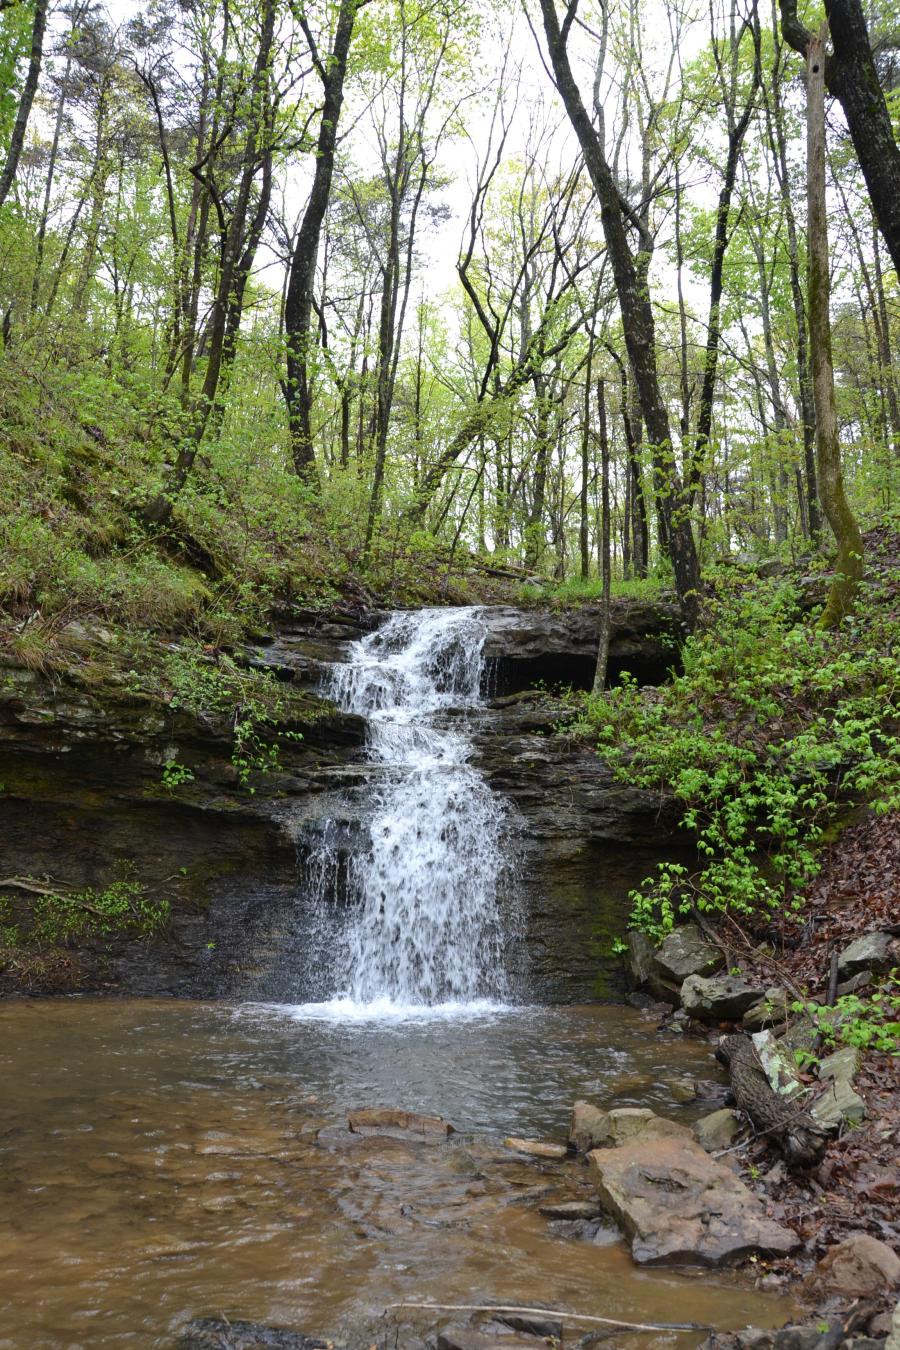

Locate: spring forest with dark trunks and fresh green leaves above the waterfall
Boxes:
[0,0,900,626]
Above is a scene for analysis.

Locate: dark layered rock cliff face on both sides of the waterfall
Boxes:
[0,603,676,1002]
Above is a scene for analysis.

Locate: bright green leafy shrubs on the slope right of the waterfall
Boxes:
[569,574,900,937]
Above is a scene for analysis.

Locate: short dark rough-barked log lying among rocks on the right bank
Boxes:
[715,1035,827,1168]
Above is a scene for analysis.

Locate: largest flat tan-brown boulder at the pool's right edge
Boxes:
[590,1119,799,1266]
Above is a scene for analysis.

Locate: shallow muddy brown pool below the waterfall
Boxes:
[0,999,791,1350]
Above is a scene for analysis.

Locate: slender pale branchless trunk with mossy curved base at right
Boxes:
[807,27,862,628]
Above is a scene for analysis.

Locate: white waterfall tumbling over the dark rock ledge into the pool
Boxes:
[323,608,505,1006]
